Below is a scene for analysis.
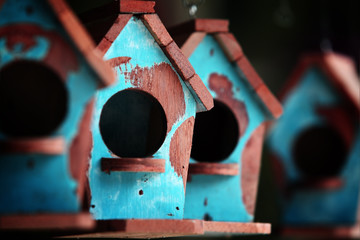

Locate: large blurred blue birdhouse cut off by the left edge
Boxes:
[0,0,114,230]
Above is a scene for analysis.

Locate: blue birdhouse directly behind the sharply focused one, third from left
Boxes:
[170,19,282,233]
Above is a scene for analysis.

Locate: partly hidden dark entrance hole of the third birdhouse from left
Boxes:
[191,100,239,162]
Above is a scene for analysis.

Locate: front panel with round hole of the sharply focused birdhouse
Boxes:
[89,16,197,220]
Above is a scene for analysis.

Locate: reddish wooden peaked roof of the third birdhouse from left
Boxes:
[170,19,282,118]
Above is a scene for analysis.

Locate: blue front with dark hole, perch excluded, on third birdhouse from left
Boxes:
[185,35,271,222]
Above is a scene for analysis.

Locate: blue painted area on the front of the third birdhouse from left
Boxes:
[185,35,271,222]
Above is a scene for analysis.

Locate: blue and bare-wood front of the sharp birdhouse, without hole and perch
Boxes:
[89,17,196,220]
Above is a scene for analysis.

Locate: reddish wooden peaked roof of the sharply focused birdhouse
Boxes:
[79,0,214,112]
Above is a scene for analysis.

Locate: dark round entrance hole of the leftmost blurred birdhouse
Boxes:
[0,60,68,137]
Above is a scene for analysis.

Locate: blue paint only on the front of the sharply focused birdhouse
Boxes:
[89,17,196,219]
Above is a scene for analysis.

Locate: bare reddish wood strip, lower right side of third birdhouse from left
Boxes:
[241,124,265,216]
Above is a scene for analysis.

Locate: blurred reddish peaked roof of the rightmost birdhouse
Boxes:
[280,52,360,110]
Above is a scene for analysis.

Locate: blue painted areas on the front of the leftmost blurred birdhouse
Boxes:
[0,0,97,214]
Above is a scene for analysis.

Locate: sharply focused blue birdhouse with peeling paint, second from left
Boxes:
[73,0,213,237]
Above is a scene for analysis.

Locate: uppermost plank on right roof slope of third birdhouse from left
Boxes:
[214,33,244,62]
